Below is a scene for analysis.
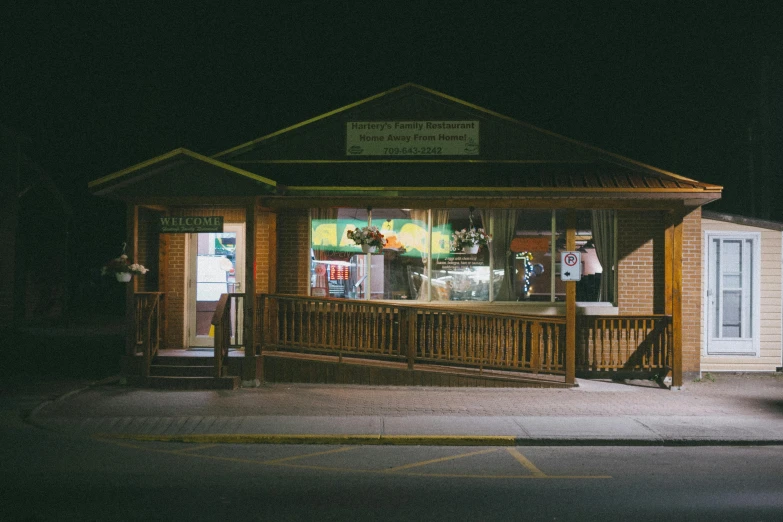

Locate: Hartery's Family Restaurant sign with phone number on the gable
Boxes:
[345,120,479,156]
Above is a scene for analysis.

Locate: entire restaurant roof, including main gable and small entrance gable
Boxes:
[89,83,722,208]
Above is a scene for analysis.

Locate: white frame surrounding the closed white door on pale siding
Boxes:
[702,230,761,357]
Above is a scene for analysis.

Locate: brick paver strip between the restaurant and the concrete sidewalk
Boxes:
[39,374,783,417]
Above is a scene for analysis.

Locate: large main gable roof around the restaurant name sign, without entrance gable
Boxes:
[213,83,722,199]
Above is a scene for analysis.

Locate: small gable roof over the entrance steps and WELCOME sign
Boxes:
[88,148,277,198]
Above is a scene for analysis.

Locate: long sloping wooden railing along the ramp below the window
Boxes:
[256,295,565,374]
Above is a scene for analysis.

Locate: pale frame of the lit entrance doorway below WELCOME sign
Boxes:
[183,223,247,349]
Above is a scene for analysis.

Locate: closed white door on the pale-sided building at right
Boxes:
[706,233,759,355]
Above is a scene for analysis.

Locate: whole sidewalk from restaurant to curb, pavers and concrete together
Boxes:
[28,374,783,445]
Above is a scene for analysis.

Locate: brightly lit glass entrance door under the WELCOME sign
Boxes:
[187,223,245,347]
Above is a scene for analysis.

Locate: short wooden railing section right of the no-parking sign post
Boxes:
[576,315,673,378]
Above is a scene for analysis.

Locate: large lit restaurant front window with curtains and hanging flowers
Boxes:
[310,208,614,302]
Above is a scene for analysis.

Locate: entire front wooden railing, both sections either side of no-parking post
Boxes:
[255,294,673,376]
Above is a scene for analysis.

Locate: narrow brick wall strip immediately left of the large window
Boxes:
[277,209,310,295]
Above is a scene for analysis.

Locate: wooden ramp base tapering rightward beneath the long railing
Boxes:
[263,351,574,388]
